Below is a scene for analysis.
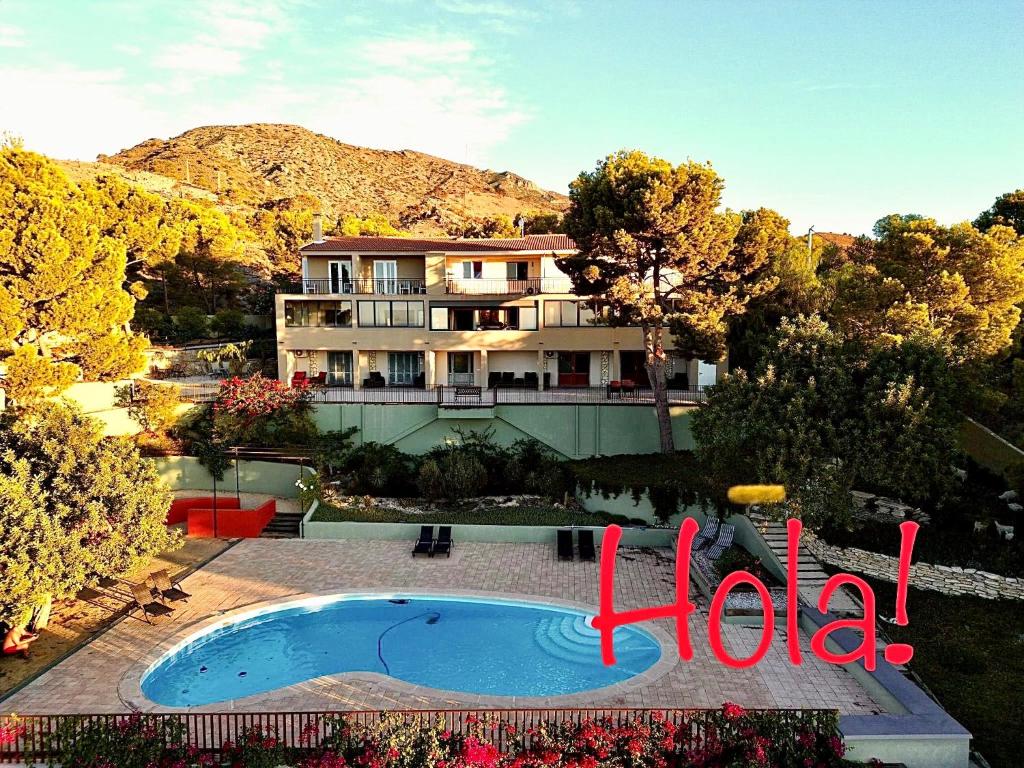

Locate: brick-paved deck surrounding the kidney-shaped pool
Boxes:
[0,539,884,715]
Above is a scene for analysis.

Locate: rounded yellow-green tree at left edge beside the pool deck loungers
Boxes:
[0,402,180,620]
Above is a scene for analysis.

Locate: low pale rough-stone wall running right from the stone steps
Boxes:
[803,530,1024,600]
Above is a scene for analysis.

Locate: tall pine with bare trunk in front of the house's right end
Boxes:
[559,151,784,452]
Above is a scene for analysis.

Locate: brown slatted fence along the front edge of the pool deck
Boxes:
[0,709,839,763]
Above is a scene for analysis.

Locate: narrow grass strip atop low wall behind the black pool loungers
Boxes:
[312,504,628,525]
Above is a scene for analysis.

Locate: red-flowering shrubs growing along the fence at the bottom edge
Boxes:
[34,703,846,768]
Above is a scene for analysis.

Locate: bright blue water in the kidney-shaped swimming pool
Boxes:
[142,595,660,707]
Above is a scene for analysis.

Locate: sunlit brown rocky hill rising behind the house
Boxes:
[99,124,568,234]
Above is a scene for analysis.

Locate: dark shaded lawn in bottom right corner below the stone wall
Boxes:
[868,579,1024,768]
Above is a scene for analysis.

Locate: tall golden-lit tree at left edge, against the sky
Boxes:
[0,146,146,401]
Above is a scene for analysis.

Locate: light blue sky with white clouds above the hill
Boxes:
[0,0,1024,233]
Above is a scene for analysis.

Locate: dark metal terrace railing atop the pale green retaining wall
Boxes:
[169,374,708,408]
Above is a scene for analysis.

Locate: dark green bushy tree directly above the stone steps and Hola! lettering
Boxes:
[691,316,961,521]
